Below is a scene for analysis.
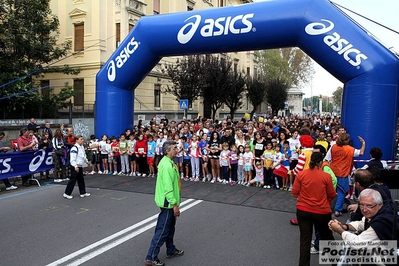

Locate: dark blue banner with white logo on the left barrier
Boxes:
[0,149,54,179]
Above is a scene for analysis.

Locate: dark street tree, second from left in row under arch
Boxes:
[202,55,231,120]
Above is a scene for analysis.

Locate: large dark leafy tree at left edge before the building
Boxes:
[0,0,80,117]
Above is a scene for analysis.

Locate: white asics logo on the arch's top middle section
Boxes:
[177,13,254,44]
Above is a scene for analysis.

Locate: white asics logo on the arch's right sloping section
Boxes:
[305,19,368,68]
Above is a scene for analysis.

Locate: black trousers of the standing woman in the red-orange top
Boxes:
[296,209,334,266]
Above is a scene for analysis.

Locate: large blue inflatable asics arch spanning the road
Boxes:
[95,0,399,159]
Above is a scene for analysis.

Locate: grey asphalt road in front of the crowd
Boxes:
[0,175,346,266]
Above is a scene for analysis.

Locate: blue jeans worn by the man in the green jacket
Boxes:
[146,208,176,260]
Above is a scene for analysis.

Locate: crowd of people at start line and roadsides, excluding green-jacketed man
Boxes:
[0,116,396,265]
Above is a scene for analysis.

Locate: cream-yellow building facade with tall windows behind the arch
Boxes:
[37,0,257,121]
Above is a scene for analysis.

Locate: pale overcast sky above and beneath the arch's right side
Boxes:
[254,0,399,97]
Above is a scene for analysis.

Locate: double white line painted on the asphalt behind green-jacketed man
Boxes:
[46,199,202,266]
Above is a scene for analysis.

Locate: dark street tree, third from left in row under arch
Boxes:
[224,71,245,119]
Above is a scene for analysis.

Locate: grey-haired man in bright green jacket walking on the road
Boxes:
[144,140,184,266]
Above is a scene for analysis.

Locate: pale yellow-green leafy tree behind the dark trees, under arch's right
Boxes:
[256,47,314,88]
